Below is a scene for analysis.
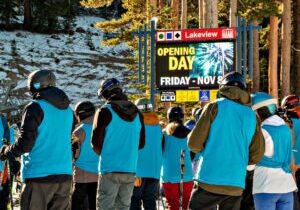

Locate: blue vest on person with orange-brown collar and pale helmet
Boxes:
[136,124,162,179]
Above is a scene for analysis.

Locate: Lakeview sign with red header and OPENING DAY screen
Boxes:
[155,28,236,91]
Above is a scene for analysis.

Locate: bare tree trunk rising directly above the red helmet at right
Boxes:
[280,0,292,97]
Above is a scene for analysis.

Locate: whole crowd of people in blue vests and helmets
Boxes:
[0,70,300,210]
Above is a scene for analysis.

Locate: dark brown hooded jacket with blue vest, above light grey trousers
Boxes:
[92,96,145,173]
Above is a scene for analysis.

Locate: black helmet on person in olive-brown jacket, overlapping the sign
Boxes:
[220,72,247,90]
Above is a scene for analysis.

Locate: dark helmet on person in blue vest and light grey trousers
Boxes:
[98,78,122,99]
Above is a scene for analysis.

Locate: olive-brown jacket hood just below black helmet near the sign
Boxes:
[219,86,251,106]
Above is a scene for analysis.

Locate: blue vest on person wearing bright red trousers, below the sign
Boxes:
[161,131,193,183]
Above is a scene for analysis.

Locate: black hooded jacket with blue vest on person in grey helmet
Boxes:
[6,87,74,183]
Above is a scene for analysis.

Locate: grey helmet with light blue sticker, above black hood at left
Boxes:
[27,70,56,93]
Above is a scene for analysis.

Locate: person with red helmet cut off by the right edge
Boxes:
[281,94,300,210]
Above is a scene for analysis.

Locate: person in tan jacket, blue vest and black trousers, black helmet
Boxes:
[72,101,99,210]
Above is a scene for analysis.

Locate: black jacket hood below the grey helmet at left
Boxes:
[33,87,70,109]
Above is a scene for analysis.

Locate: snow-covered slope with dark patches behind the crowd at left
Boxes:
[0,16,136,105]
